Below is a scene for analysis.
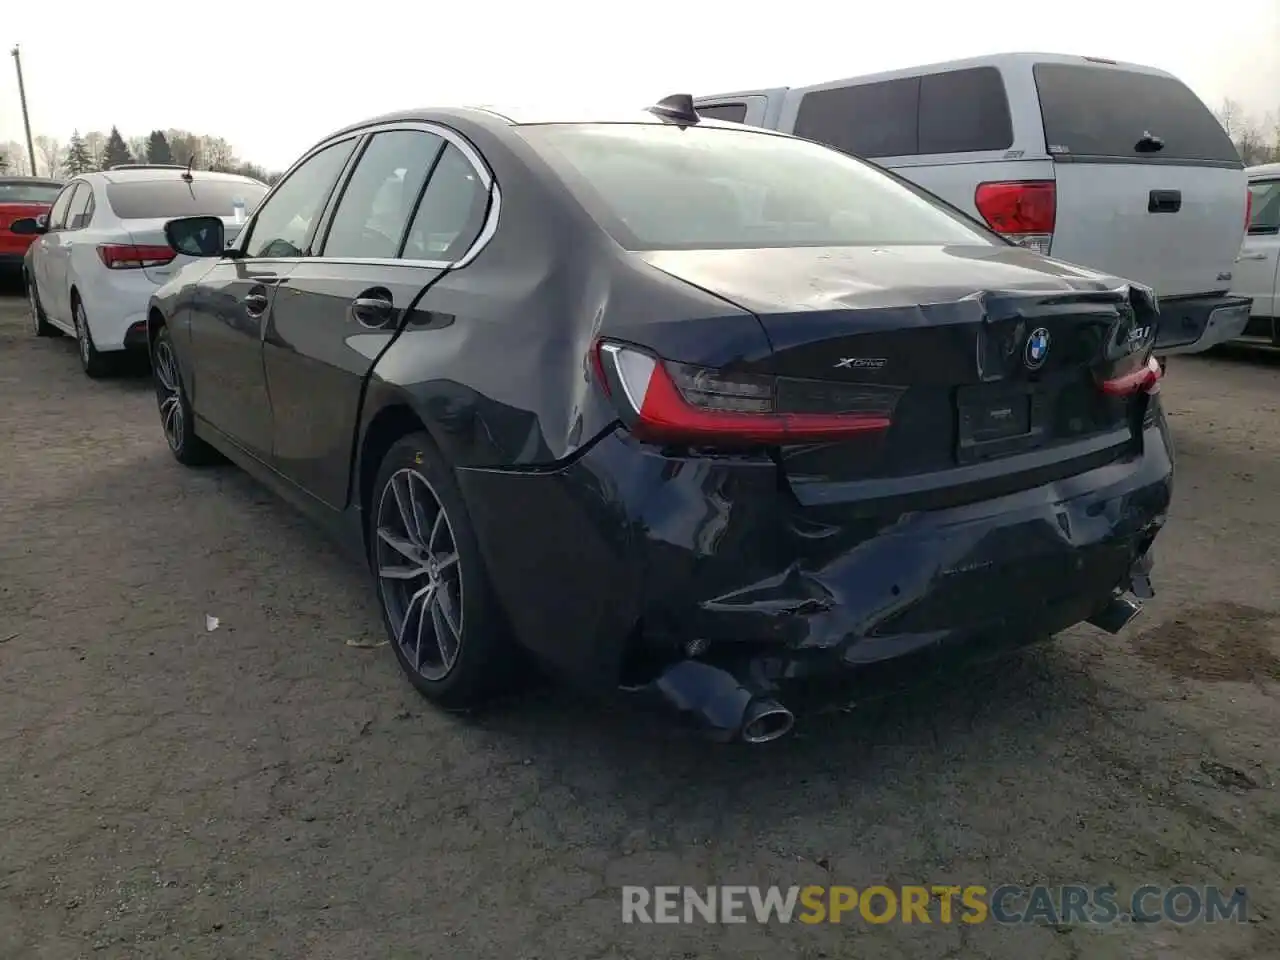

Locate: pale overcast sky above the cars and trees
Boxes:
[0,0,1280,169]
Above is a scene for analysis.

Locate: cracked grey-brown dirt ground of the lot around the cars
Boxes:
[0,288,1280,960]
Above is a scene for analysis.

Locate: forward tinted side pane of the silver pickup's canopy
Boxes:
[795,77,920,157]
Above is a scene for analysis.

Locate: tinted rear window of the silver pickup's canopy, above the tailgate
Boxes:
[1034,63,1240,164]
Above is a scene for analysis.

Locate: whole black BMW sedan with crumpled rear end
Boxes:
[148,96,1172,741]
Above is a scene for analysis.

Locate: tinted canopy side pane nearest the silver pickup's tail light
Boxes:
[918,67,1014,154]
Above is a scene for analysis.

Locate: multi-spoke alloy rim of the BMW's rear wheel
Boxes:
[374,467,462,681]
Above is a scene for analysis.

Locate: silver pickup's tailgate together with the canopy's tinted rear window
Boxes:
[1033,63,1248,297]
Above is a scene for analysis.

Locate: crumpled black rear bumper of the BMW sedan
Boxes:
[460,416,1172,740]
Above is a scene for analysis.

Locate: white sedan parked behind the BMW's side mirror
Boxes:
[9,164,268,378]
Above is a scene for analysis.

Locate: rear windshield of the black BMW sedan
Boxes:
[517,123,997,250]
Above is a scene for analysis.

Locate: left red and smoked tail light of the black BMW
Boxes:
[593,340,902,445]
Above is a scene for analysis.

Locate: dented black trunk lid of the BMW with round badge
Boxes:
[643,246,1155,502]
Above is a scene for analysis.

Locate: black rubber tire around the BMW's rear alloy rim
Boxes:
[369,433,521,710]
